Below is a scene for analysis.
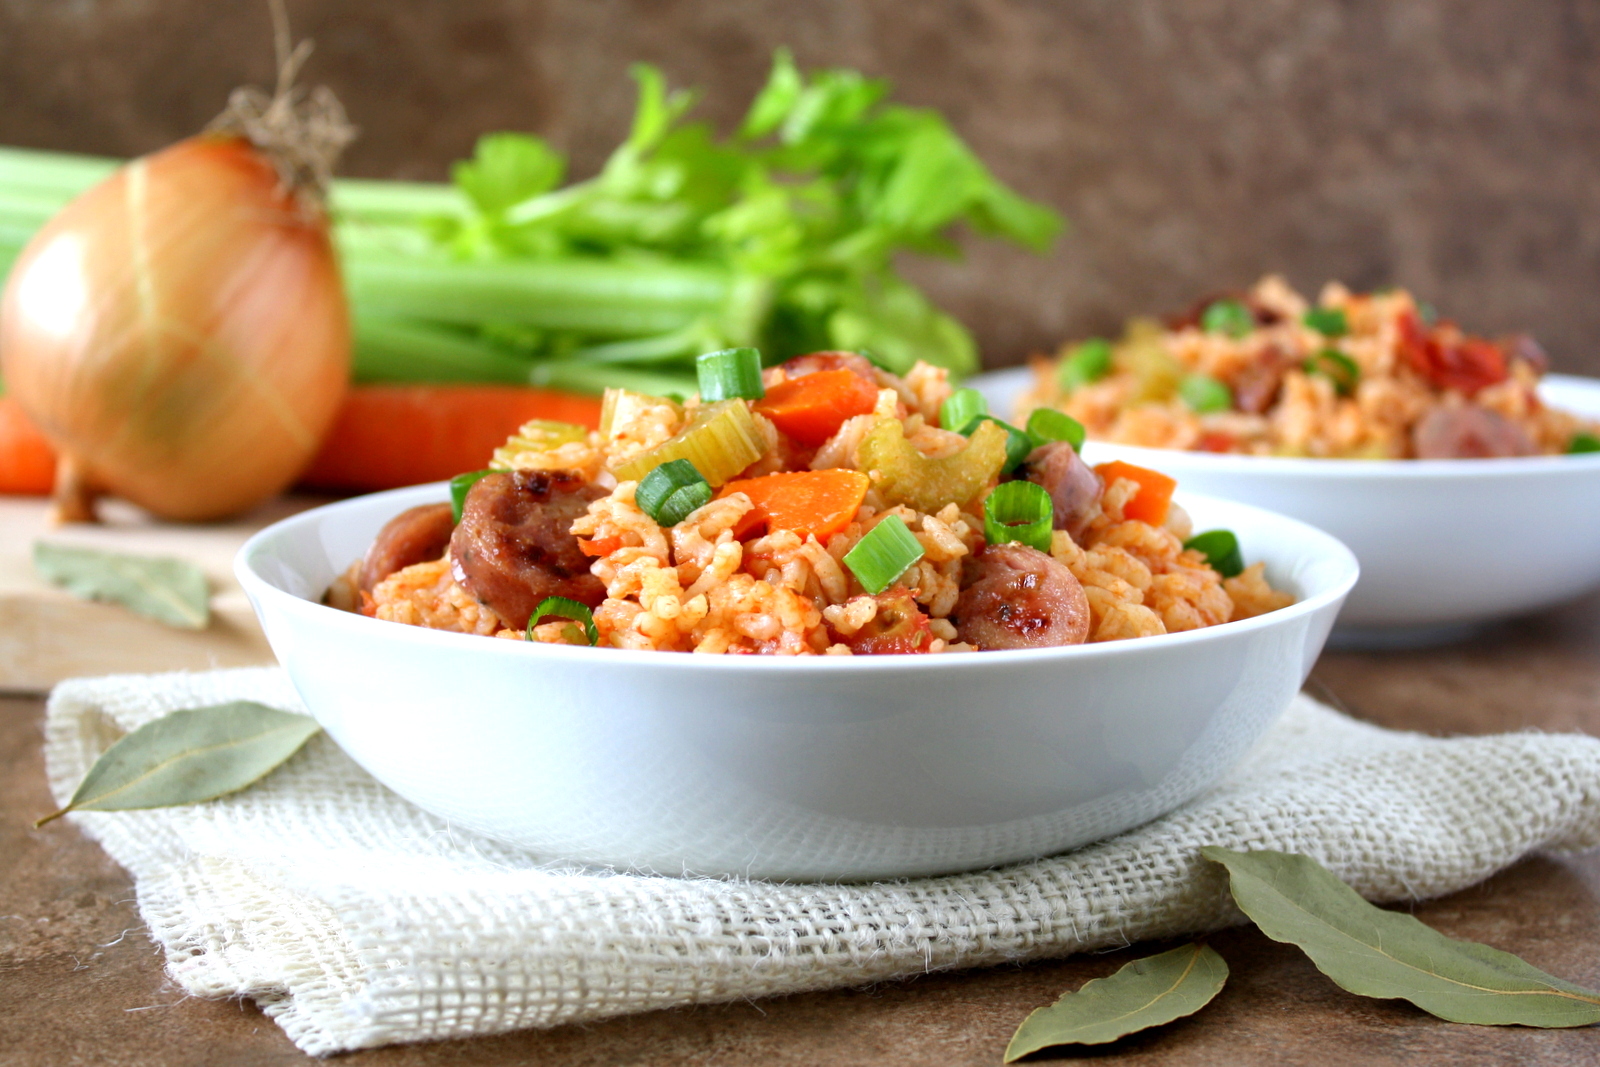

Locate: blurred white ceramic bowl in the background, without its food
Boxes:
[970,370,1600,646]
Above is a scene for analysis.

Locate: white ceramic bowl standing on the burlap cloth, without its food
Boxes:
[235,485,1357,880]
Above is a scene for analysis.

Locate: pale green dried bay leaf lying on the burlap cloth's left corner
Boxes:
[34,701,322,827]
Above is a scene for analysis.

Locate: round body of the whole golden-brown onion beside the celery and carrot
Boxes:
[0,134,350,520]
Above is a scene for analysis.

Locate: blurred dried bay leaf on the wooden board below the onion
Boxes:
[34,541,211,630]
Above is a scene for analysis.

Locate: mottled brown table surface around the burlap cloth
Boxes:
[0,597,1600,1067]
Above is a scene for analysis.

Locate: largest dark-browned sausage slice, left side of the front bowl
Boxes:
[450,470,606,629]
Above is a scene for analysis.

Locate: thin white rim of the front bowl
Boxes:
[234,482,1360,672]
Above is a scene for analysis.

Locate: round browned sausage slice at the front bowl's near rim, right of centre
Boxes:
[955,544,1090,649]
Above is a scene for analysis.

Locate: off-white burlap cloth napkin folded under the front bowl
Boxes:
[46,670,1600,1054]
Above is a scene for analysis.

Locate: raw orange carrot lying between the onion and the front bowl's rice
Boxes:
[301,386,600,491]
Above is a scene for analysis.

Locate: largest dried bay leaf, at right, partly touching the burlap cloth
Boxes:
[1200,845,1600,1027]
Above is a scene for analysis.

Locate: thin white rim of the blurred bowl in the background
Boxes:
[968,366,1600,478]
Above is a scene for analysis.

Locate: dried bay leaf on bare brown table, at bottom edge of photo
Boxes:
[1005,942,1227,1064]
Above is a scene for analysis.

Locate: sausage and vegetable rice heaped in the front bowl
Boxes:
[328,349,1293,656]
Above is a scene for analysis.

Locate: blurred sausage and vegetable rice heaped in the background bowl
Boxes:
[1021,277,1600,459]
